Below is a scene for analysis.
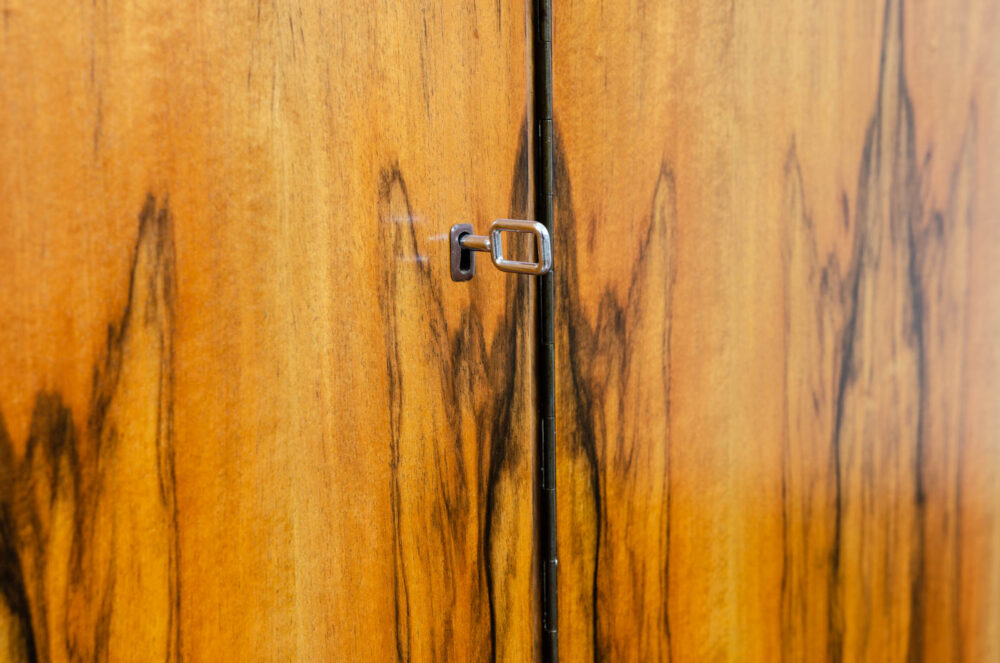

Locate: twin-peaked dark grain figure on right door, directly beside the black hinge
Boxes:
[555,133,676,661]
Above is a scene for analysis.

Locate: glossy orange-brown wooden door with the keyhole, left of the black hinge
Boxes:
[0,0,534,661]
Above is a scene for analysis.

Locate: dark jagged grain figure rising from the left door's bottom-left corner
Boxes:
[0,195,180,661]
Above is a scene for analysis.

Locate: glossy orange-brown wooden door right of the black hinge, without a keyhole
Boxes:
[554,0,1000,661]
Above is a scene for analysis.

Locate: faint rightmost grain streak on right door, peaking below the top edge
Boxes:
[910,113,977,661]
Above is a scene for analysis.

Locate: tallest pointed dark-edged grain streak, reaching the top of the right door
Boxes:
[830,6,923,660]
